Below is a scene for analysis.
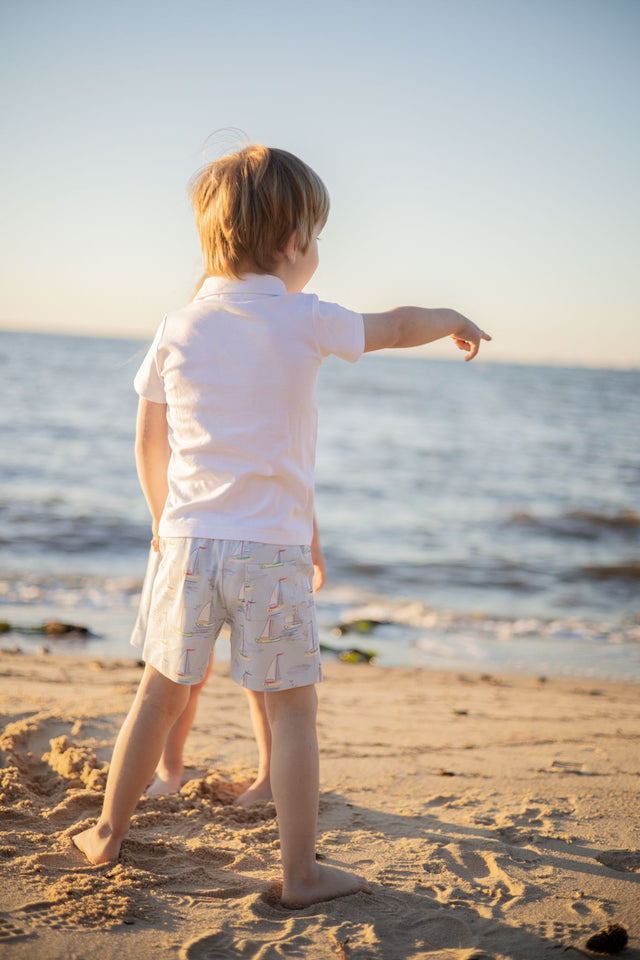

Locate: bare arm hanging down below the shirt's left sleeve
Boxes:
[136,397,171,552]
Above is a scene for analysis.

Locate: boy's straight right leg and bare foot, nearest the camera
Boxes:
[265,685,368,907]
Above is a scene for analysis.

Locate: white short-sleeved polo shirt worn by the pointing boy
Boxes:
[134,274,364,545]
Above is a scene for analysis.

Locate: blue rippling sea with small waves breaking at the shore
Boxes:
[0,332,640,681]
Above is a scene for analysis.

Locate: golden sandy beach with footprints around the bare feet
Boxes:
[0,653,640,960]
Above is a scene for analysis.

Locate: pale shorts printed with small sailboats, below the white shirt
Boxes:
[131,537,322,691]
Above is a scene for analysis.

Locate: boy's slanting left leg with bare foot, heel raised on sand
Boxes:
[73,664,190,864]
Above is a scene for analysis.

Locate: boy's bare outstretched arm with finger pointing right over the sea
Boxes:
[363,307,491,360]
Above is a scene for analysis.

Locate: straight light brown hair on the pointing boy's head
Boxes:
[191,144,329,279]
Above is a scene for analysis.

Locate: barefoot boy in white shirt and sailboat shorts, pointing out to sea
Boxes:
[74,145,490,907]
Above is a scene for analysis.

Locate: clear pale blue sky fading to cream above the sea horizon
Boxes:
[0,0,640,368]
